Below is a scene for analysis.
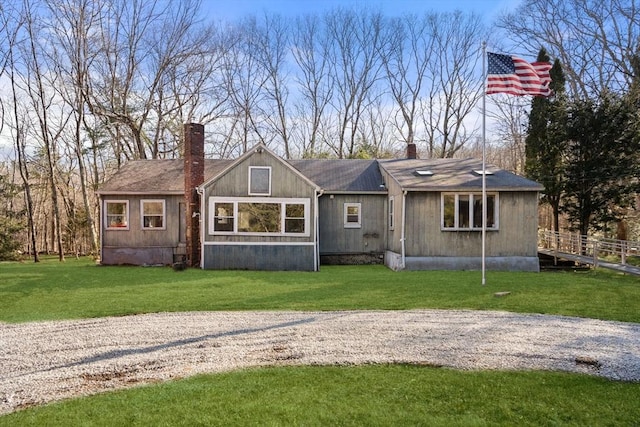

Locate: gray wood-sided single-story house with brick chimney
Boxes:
[98,124,542,271]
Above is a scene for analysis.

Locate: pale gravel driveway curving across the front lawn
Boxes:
[0,310,640,414]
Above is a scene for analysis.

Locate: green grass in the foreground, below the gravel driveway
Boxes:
[0,365,640,426]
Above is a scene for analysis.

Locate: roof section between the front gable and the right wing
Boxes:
[287,159,386,193]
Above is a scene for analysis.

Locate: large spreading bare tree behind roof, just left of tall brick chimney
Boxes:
[87,0,206,159]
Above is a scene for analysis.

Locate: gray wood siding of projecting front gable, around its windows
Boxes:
[202,148,318,271]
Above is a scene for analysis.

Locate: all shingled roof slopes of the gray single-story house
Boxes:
[98,159,543,195]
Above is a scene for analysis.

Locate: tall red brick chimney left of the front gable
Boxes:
[184,123,204,267]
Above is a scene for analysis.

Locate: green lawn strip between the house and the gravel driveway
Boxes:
[0,258,640,323]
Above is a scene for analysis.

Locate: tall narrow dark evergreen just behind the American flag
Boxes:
[525,48,567,231]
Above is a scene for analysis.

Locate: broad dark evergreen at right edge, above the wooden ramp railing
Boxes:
[562,94,640,239]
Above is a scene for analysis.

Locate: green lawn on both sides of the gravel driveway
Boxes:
[0,259,640,426]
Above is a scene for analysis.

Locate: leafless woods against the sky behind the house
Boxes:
[0,0,640,260]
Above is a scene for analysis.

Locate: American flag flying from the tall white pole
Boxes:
[487,52,552,97]
